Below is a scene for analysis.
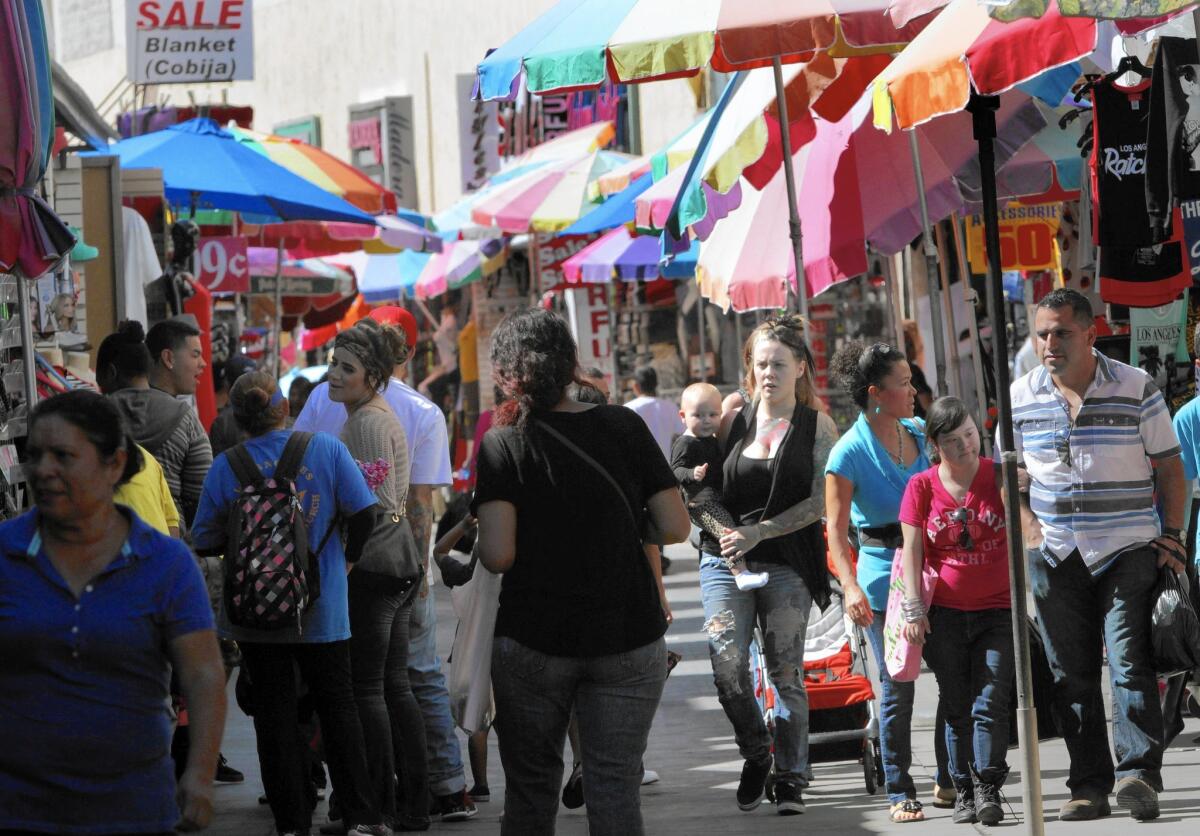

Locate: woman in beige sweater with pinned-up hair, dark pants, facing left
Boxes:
[329,319,430,830]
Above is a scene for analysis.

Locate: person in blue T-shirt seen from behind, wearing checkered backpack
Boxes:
[192,372,391,834]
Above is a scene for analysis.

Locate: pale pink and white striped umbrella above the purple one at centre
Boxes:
[470,151,630,234]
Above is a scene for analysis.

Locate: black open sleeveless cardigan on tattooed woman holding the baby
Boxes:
[722,401,830,609]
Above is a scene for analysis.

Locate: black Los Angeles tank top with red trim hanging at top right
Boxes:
[1091,80,1166,247]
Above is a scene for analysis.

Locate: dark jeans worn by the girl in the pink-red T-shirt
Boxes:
[925,607,1014,787]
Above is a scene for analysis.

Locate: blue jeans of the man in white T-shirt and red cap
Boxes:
[408,585,467,795]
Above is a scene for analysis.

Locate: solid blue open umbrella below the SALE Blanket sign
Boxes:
[82,119,374,224]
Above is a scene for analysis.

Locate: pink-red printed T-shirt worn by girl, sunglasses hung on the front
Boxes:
[900,458,1010,611]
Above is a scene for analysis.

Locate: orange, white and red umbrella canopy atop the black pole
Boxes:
[875,0,1097,131]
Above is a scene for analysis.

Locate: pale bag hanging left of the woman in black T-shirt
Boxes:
[448,561,500,734]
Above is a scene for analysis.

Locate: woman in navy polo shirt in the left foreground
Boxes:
[0,391,226,834]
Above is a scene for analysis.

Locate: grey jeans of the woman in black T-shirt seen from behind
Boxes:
[492,636,667,836]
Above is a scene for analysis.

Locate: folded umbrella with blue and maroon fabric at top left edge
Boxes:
[0,0,76,278]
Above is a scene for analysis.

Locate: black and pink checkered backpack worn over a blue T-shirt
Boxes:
[224,433,334,633]
